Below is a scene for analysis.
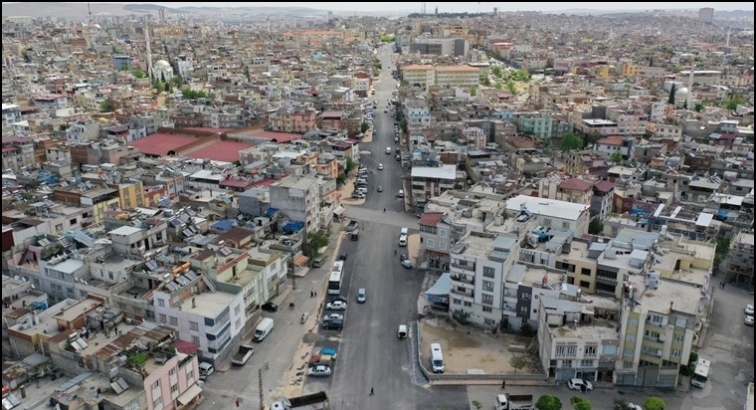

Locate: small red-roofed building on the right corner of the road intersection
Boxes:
[417,212,451,271]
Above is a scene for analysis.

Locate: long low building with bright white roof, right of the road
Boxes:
[507,195,590,237]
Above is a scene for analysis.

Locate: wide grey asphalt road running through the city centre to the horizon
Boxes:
[304,43,469,410]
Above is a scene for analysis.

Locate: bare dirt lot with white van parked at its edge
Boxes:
[420,319,542,374]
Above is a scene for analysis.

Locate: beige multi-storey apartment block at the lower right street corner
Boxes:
[615,271,708,388]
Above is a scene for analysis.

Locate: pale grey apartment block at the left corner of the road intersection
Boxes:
[269,176,321,232]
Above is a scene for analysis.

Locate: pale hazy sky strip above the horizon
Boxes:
[3,1,754,13]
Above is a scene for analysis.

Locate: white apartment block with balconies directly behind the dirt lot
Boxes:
[449,232,520,329]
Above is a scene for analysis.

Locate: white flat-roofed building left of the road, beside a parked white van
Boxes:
[154,286,245,362]
